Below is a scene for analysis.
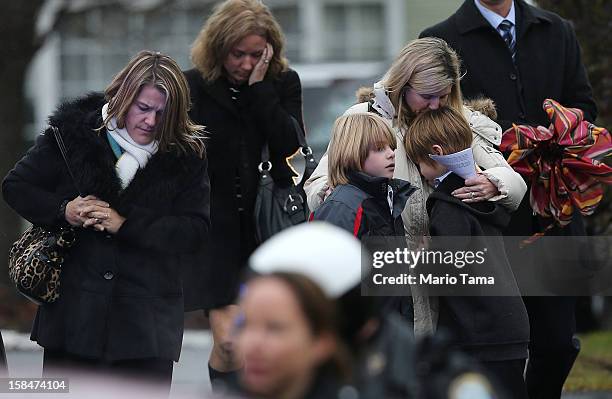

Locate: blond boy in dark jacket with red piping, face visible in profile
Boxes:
[310,113,415,239]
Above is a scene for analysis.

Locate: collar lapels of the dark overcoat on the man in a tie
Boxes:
[455,0,551,39]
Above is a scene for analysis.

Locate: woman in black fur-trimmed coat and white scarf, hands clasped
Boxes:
[2,51,210,388]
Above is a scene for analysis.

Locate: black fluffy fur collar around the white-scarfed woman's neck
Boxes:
[45,93,204,213]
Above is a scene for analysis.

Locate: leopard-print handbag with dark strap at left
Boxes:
[9,126,85,305]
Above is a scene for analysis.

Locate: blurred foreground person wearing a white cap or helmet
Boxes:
[246,222,500,399]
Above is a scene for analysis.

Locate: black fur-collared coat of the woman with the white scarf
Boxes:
[2,94,210,360]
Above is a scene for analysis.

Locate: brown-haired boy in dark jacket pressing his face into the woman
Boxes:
[405,107,529,398]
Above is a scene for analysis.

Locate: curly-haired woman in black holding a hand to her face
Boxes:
[185,0,303,388]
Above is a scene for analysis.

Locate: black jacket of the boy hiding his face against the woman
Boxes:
[427,173,529,361]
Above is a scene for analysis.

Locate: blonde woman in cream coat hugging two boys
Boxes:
[305,38,527,336]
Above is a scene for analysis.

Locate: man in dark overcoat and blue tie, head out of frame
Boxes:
[421,0,597,399]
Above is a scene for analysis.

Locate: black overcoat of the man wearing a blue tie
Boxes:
[420,0,597,129]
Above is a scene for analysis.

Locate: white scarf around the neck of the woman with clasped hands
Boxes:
[102,103,158,189]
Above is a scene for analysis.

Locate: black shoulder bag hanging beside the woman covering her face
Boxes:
[254,117,318,244]
